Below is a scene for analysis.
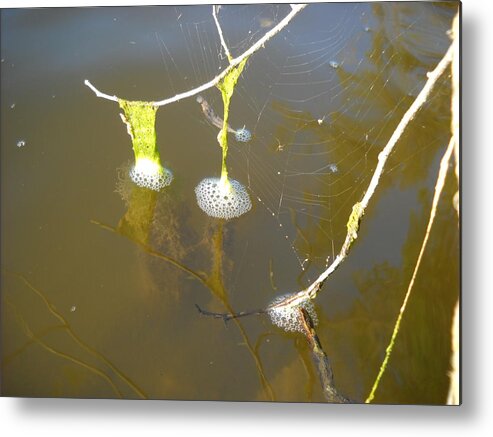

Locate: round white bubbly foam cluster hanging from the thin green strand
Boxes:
[195,178,252,220]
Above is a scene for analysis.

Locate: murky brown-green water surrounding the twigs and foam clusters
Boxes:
[1,3,460,404]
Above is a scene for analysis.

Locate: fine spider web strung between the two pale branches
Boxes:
[150,3,453,290]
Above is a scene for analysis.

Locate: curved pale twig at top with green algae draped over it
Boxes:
[84,4,306,106]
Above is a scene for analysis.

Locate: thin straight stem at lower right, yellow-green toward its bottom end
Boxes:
[365,136,455,404]
